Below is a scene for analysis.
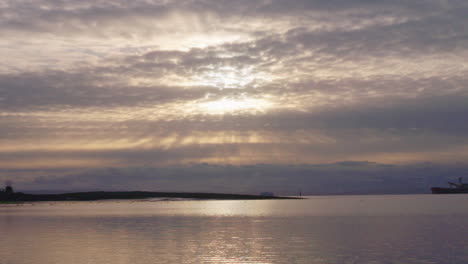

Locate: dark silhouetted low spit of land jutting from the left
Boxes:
[0,191,300,202]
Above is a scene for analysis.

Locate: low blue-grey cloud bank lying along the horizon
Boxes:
[7,162,467,195]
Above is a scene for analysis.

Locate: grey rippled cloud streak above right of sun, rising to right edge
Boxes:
[228,14,468,70]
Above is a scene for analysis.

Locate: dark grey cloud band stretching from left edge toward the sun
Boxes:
[0,72,213,111]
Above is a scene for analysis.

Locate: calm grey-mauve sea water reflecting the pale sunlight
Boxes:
[0,195,468,264]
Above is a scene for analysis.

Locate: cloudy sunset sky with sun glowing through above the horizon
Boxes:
[0,0,468,194]
